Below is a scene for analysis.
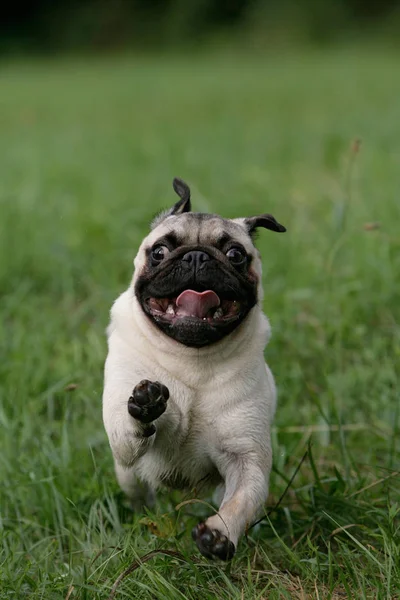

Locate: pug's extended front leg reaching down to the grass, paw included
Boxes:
[192,451,271,560]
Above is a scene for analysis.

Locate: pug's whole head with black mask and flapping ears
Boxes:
[133,179,285,348]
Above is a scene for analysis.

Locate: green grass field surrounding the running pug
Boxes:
[0,51,400,600]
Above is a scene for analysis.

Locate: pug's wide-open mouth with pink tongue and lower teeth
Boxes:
[146,289,241,325]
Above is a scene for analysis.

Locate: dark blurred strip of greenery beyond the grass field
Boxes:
[0,0,400,53]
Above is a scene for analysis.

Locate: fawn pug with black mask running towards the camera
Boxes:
[103,178,286,560]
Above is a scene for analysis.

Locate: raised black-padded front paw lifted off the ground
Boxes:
[128,379,169,423]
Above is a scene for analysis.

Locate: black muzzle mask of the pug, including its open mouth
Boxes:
[135,243,257,348]
